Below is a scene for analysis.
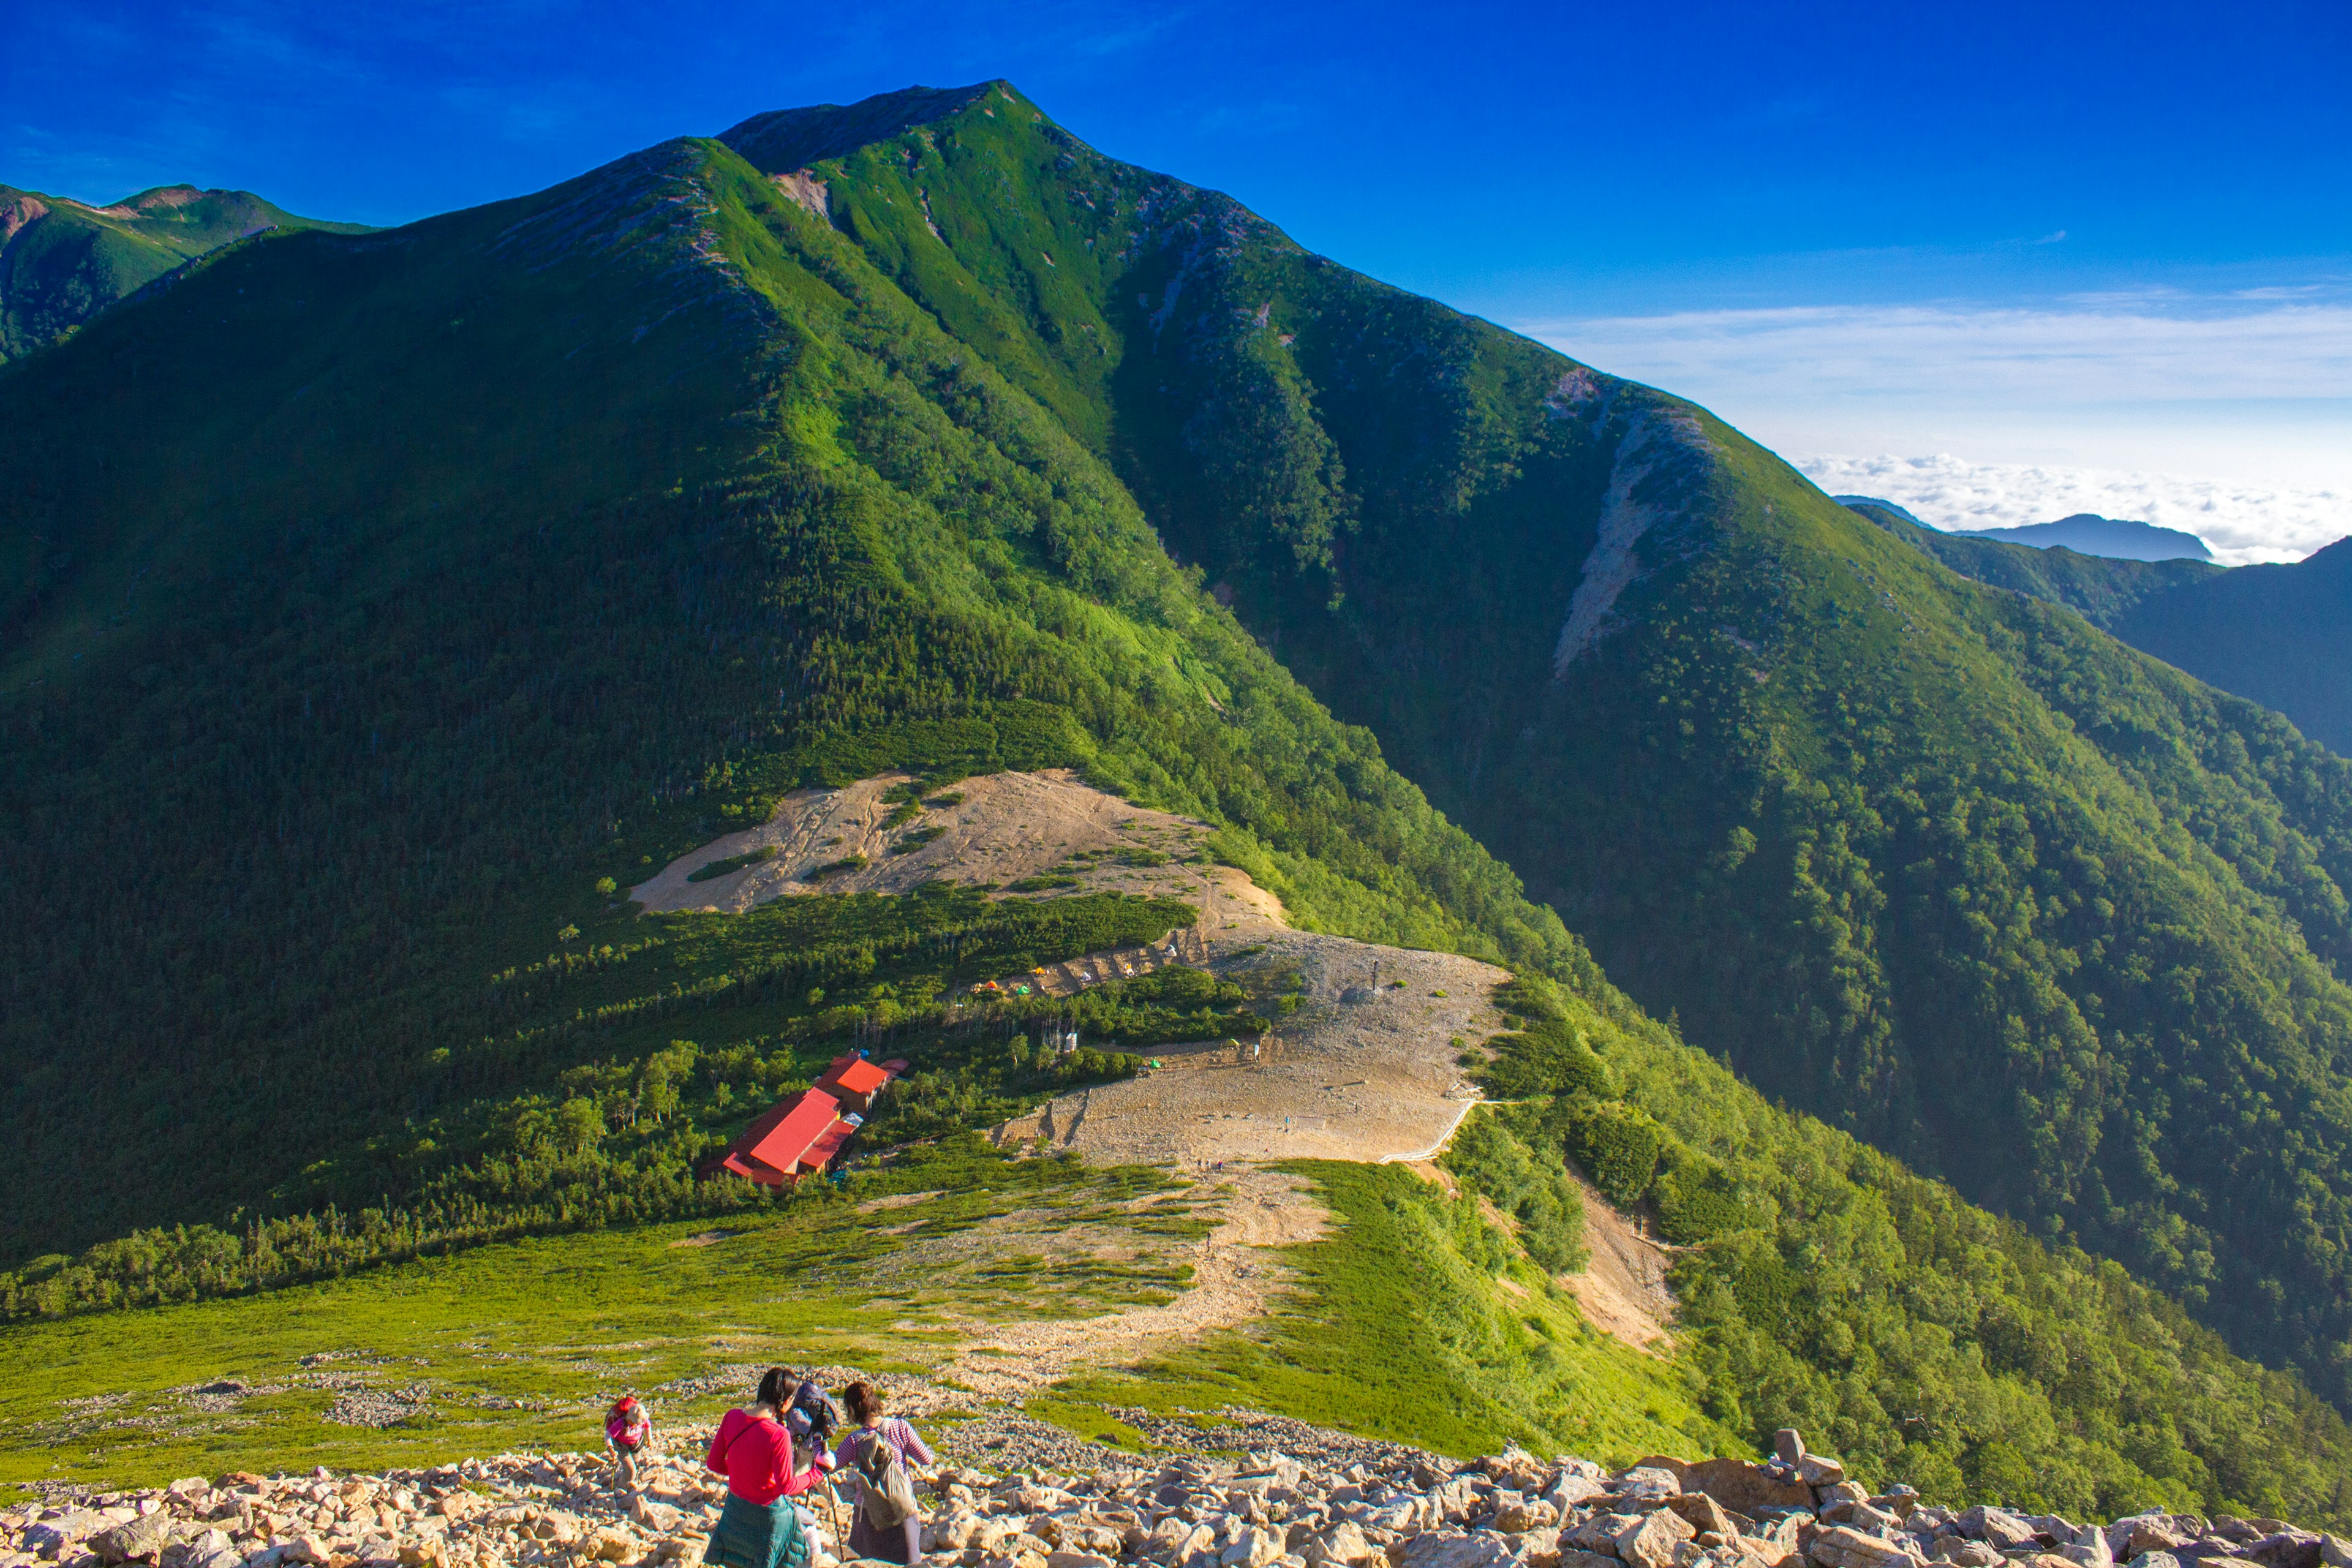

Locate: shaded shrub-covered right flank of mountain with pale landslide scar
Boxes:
[727,89,2352,1399]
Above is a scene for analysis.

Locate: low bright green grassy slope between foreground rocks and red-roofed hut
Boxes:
[0,1150,1727,1483]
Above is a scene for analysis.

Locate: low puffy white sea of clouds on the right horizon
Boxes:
[1790,454,2352,567]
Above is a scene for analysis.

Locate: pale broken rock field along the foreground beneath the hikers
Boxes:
[0,1422,2352,1568]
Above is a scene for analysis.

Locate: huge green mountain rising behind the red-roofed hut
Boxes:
[0,82,2352,1521]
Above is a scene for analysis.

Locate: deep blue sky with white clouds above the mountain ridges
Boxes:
[0,0,2352,559]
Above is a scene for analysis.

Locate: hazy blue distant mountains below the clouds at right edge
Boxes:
[1837,496,2352,757]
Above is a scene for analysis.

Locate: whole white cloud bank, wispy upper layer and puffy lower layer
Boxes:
[1521,293,2352,562]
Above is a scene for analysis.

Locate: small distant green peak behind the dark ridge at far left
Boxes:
[0,186,367,360]
